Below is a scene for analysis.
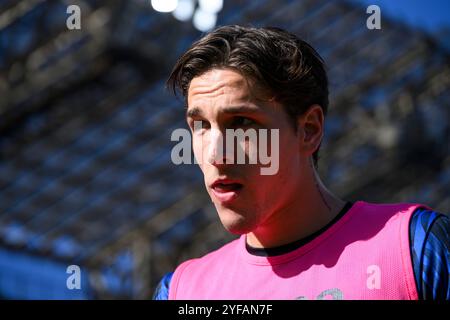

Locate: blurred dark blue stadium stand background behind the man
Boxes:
[0,0,450,299]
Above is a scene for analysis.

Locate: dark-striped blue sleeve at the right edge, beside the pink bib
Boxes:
[409,209,450,300]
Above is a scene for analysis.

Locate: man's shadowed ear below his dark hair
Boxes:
[298,104,324,156]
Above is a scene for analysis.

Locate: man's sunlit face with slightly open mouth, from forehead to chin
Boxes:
[187,69,305,234]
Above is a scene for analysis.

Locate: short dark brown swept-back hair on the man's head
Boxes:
[167,25,328,168]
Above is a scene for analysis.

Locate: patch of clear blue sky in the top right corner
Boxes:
[355,0,450,32]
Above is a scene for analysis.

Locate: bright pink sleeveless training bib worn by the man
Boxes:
[169,201,430,300]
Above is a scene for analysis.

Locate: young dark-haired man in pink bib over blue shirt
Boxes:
[154,26,450,299]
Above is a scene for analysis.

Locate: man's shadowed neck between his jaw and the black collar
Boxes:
[247,161,345,248]
